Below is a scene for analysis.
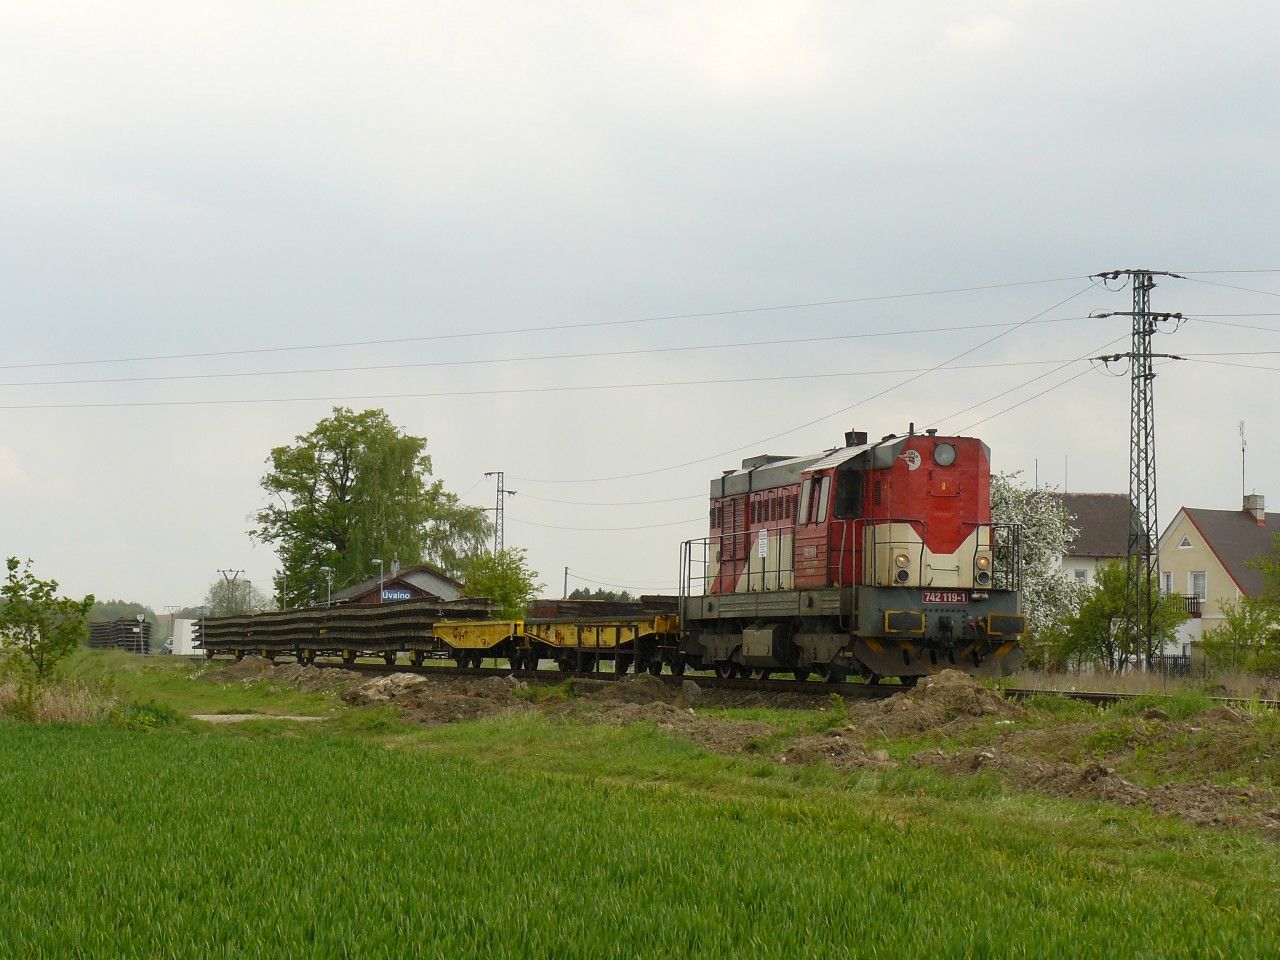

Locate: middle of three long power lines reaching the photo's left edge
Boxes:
[0,316,1092,387]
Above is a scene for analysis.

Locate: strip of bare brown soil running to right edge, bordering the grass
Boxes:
[914,748,1280,838]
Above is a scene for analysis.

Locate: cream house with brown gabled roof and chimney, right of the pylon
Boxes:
[1160,493,1280,643]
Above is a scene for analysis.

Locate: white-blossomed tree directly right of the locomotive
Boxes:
[991,471,1080,634]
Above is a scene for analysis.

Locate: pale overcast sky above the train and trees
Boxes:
[0,0,1280,608]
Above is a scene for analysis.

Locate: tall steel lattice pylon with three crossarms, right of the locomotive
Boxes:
[1094,269,1183,668]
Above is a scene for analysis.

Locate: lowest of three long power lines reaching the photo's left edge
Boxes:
[0,360,1100,410]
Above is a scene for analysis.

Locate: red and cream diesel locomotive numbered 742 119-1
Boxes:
[680,426,1027,682]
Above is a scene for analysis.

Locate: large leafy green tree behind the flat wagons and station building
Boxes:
[250,407,492,605]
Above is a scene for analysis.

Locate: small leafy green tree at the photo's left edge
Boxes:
[0,557,93,681]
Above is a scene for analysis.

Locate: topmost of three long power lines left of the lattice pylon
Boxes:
[0,275,1085,370]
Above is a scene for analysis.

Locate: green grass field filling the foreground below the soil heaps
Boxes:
[0,712,1280,957]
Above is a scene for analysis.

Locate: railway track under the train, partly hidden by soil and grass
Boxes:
[299,662,1280,710]
